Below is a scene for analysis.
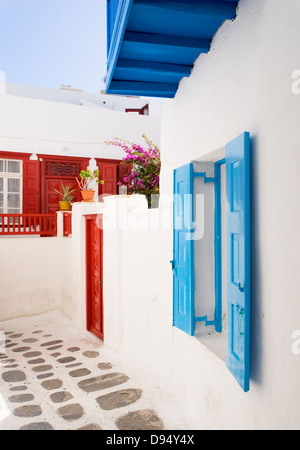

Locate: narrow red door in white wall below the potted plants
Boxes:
[86,215,104,340]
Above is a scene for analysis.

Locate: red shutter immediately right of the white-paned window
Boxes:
[23,159,40,214]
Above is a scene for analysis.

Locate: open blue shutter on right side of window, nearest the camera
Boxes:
[226,132,250,392]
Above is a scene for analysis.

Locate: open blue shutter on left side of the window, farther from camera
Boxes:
[172,164,195,336]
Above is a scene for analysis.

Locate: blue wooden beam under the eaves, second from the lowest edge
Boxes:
[114,59,191,83]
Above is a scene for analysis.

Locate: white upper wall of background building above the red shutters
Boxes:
[0,90,161,159]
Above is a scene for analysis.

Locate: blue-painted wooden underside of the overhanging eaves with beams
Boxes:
[106,0,238,98]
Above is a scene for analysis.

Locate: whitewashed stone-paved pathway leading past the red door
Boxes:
[0,312,190,430]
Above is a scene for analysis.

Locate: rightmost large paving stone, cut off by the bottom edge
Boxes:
[116,409,164,430]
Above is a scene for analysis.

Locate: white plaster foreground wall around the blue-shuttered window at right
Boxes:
[160,0,300,428]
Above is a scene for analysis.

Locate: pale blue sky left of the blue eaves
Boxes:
[0,0,106,92]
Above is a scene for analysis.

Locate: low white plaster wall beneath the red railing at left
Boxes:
[0,237,71,321]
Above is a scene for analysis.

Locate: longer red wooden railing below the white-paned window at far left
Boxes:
[0,214,57,236]
